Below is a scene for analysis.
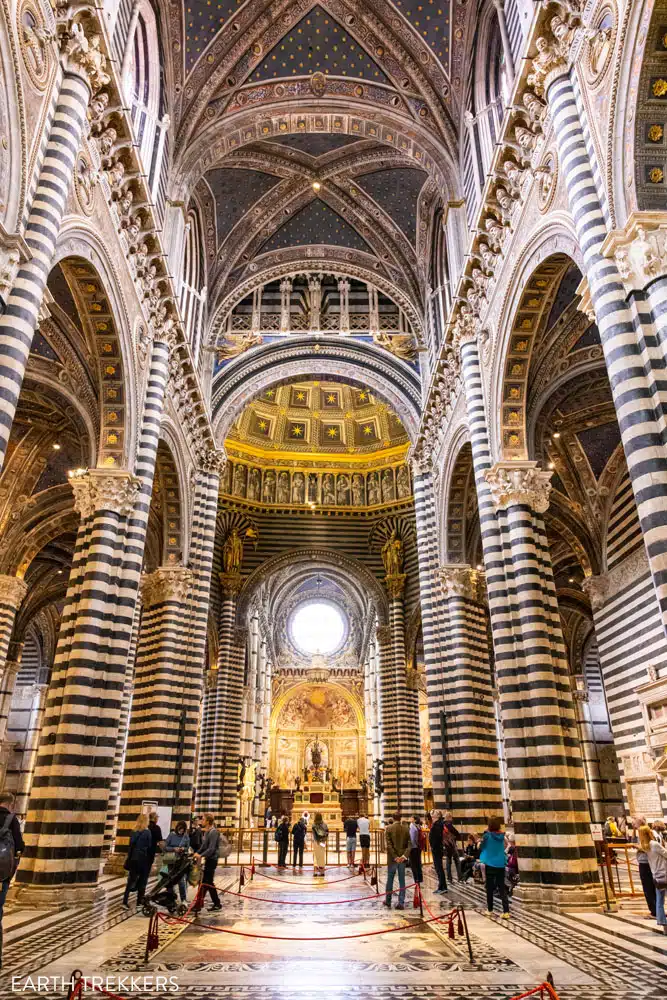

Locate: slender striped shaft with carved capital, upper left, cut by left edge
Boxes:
[0,24,109,469]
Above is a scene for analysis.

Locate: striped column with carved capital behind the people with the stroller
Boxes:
[116,566,197,852]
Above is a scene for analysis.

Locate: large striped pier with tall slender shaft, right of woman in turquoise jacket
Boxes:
[459,329,600,907]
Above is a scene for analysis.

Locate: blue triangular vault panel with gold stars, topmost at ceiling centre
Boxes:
[249,6,389,84]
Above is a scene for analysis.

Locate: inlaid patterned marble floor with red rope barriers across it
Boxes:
[5,869,667,1000]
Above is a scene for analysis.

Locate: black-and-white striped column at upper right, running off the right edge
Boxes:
[544,62,667,631]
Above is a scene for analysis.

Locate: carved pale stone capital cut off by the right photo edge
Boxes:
[602,212,667,293]
